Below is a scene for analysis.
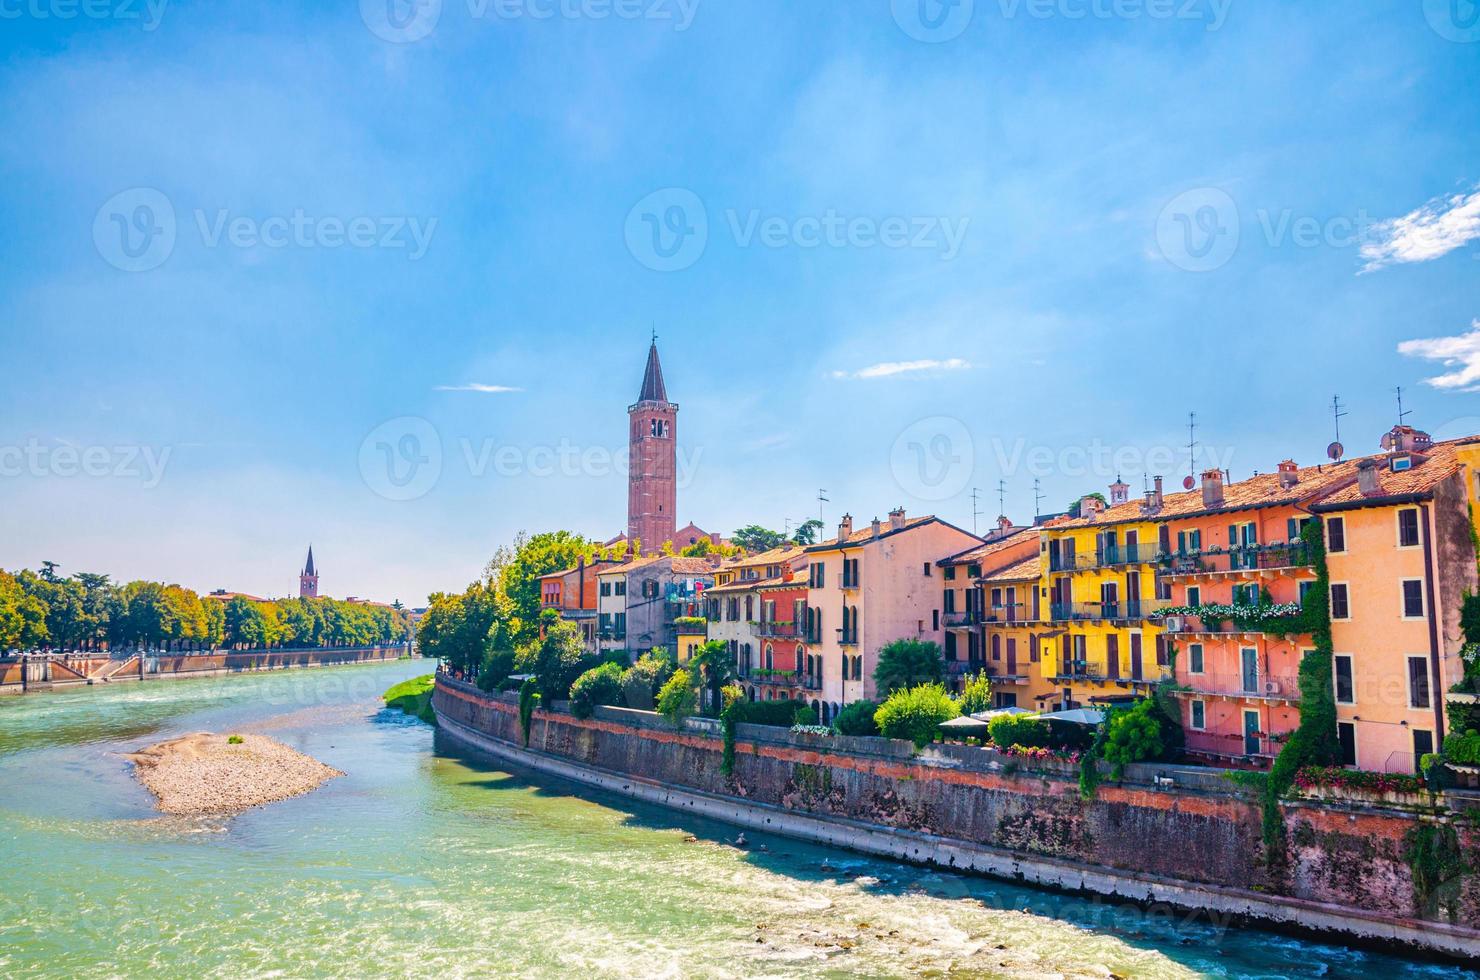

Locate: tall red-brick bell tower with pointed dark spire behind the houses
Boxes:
[628,333,678,555]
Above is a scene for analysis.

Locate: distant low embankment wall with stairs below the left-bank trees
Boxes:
[0,644,411,694]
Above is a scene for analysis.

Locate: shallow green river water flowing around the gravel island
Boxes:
[0,662,1476,980]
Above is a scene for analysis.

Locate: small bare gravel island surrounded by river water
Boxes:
[127,731,343,816]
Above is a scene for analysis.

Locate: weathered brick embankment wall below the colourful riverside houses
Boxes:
[434,678,1480,958]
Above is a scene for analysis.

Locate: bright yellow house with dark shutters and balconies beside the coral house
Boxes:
[1035,478,1171,708]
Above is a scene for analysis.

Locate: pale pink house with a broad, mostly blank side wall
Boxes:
[805,508,983,724]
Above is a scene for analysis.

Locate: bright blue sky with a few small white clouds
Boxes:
[0,0,1480,605]
